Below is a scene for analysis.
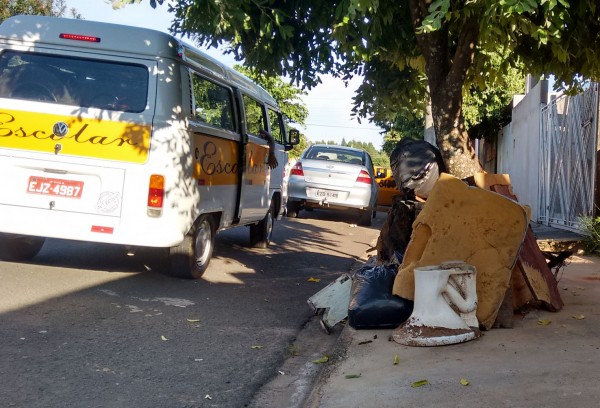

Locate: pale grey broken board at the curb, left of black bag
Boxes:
[308,273,352,334]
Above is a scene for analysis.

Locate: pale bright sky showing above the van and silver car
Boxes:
[66,0,383,149]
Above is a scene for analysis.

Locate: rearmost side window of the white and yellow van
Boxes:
[192,73,235,130]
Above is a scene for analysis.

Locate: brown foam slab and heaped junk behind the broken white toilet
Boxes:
[376,141,563,329]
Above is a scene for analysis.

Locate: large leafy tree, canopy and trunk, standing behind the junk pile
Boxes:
[113,0,600,176]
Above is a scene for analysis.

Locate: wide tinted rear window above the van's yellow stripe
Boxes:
[0,50,148,113]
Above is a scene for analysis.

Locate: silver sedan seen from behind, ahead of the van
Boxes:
[287,144,379,226]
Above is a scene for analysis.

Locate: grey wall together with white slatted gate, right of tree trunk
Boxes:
[497,81,598,230]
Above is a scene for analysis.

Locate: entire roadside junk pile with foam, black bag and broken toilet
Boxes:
[309,140,570,345]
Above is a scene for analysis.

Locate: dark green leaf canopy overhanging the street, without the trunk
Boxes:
[112,0,600,106]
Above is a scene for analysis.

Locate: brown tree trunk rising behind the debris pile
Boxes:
[410,0,482,179]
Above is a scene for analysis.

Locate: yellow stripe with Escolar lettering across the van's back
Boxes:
[0,109,150,163]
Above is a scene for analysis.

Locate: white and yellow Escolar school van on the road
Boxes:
[0,16,297,278]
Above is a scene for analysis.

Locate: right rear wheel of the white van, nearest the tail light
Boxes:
[168,215,215,279]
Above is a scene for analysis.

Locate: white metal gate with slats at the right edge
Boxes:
[538,83,598,231]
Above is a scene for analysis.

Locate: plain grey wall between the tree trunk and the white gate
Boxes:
[497,80,548,221]
